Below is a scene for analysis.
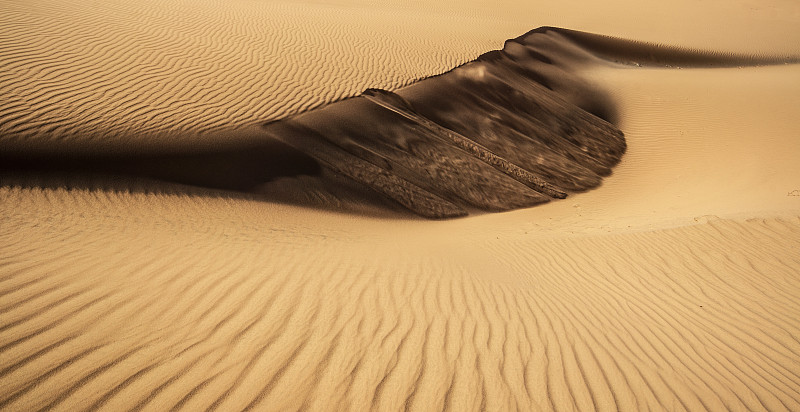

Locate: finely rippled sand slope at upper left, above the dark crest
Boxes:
[0,0,506,146]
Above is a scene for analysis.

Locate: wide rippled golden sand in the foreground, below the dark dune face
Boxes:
[0,189,800,410]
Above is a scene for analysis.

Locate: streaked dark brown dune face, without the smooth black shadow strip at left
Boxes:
[265,27,625,218]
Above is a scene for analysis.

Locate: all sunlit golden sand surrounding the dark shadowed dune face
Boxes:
[0,0,800,411]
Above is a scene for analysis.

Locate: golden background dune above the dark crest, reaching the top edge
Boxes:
[0,0,800,146]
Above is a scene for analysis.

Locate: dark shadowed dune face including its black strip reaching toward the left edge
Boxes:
[6,28,625,218]
